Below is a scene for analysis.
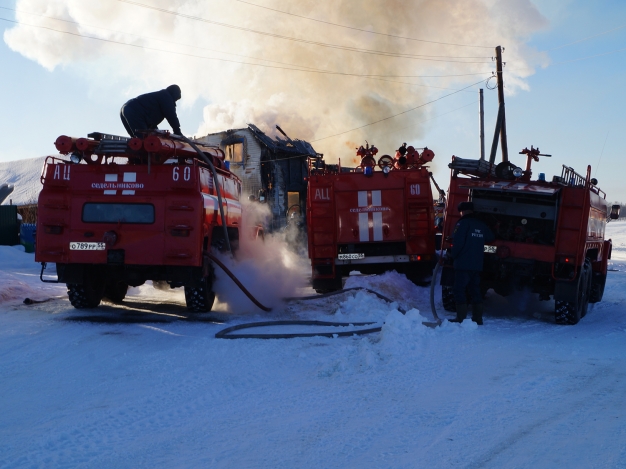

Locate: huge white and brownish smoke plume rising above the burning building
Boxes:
[4,0,547,162]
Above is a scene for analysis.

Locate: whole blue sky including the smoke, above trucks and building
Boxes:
[0,0,626,202]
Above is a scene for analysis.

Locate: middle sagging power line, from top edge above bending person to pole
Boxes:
[117,0,491,64]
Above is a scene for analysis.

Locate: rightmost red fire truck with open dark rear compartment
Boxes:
[441,147,619,324]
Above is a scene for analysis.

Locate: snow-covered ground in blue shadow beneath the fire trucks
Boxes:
[0,222,626,468]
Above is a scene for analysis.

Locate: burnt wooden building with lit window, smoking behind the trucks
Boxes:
[198,124,321,231]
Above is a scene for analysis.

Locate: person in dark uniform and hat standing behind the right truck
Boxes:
[450,202,495,325]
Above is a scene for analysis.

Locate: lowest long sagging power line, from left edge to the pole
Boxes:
[0,18,485,78]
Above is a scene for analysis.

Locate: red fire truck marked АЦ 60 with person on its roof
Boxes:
[35,131,242,312]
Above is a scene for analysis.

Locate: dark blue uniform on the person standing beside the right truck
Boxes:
[450,213,495,304]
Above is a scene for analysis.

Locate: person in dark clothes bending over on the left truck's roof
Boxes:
[120,85,182,137]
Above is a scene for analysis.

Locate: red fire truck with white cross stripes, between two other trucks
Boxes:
[307,144,435,293]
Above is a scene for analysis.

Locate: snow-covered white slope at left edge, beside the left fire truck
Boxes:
[0,156,46,205]
